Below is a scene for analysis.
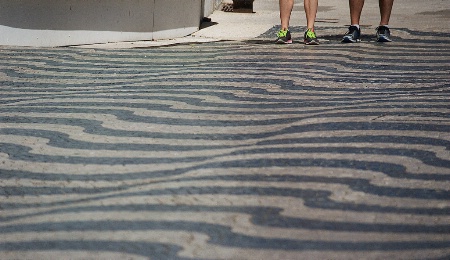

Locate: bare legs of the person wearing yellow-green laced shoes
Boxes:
[280,0,319,31]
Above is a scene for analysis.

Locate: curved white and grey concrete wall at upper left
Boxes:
[0,0,204,47]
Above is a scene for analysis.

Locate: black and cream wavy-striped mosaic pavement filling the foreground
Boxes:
[0,29,450,259]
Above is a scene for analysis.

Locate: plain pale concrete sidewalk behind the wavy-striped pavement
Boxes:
[79,0,450,48]
